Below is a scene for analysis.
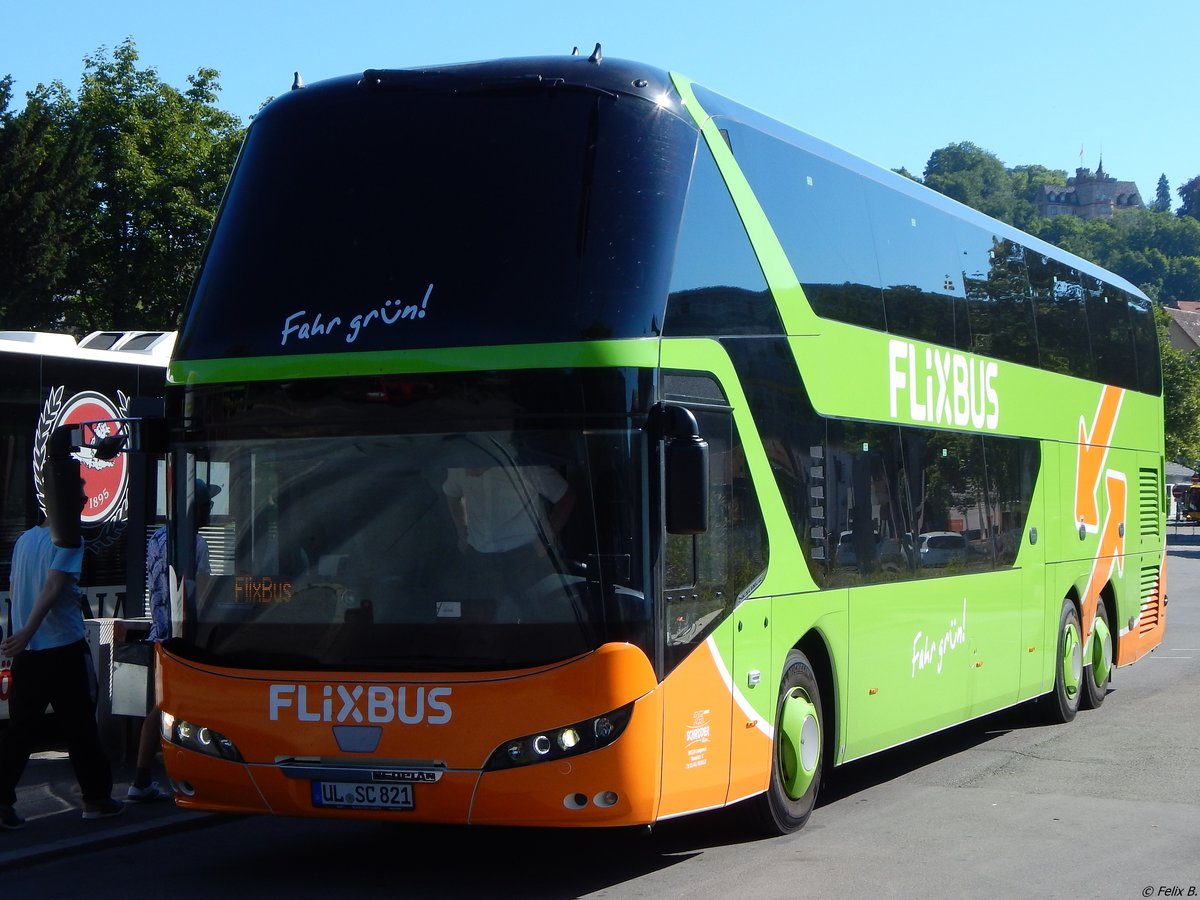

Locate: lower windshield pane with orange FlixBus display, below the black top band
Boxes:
[174,428,650,672]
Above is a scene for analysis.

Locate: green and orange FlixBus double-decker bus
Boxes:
[160,48,1165,833]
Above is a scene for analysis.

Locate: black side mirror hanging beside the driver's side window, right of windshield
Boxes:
[647,403,708,534]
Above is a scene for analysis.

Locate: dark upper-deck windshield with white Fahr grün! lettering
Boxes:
[176,82,697,359]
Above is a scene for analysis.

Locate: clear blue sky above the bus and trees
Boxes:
[0,0,1200,211]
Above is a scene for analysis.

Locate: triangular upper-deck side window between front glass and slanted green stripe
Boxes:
[662,142,784,336]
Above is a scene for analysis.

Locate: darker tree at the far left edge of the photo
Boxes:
[0,77,96,330]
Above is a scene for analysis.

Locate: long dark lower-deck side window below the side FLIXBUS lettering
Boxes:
[724,340,1038,587]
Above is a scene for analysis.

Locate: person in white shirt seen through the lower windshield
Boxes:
[442,466,575,607]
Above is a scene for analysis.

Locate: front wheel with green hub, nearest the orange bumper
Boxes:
[750,650,826,835]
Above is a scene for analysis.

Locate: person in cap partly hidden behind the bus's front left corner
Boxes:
[125,479,221,803]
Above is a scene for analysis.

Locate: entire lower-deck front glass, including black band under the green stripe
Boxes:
[164,368,657,671]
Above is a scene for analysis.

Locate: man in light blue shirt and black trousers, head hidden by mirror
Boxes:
[0,480,125,829]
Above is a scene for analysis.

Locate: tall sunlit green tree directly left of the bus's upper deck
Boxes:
[64,40,242,331]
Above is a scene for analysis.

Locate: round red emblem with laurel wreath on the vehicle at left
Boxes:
[34,386,130,545]
